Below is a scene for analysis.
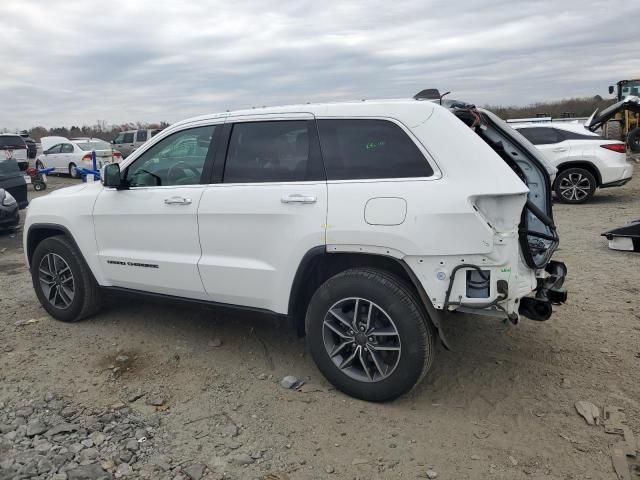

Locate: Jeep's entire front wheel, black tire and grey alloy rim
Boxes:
[31,236,100,322]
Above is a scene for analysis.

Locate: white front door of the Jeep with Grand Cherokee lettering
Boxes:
[93,125,219,298]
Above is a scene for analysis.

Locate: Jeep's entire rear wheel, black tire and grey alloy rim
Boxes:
[306,269,435,402]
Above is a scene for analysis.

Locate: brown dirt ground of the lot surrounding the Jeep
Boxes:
[0,175,640,480]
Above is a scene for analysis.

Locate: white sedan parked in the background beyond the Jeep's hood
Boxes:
[36,137,122,178]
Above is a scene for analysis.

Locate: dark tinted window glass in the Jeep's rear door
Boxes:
[223,120,324,183]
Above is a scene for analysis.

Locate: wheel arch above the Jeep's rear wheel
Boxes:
[288,246,449,349]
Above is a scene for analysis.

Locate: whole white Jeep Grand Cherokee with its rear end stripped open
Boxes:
[24,96,566,401]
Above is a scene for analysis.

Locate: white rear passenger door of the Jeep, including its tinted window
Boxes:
[198,114,327,313]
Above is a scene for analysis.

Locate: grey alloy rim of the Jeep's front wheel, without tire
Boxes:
[38,253,75,310]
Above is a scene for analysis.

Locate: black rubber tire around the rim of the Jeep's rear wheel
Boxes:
[306,268,435,402]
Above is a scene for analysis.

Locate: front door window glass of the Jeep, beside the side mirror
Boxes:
[125,125,216,187]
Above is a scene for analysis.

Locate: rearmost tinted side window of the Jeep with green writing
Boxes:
[318,119,433,180]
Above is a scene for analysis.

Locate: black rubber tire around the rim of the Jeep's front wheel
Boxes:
[31,235,101,322]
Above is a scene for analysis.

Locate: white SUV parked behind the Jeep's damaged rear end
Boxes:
[511,123,633,203]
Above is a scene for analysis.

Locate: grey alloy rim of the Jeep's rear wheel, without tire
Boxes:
[322,297,402,383]
